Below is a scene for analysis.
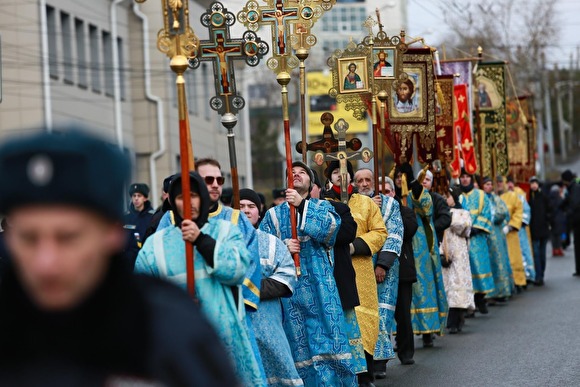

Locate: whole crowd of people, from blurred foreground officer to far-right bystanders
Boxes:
[0,129,580,386]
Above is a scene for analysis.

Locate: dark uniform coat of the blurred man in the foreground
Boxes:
[0,257,238,386]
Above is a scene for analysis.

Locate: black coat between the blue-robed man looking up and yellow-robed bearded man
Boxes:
[328,200,360,309]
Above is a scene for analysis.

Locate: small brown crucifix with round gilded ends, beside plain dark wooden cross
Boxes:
[314,113,373,203]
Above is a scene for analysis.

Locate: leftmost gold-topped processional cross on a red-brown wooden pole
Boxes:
[136,0,199,298]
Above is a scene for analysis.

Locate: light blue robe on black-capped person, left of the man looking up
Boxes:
[248,230,304,387]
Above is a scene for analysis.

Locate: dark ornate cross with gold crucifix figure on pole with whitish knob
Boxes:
[189,1,268,209]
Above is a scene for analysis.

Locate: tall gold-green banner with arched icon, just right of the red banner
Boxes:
[473,62,509,177]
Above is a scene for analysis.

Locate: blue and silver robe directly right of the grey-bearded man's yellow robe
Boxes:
[373,194,404,360]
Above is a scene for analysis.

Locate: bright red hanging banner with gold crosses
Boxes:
[451,84,477,177]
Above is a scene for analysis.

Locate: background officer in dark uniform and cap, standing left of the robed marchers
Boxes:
[124,183,155,268]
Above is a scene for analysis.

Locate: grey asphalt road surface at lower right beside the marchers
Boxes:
[375,244,580,387]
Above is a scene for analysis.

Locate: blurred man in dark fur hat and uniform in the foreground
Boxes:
[0,131,238,386]
